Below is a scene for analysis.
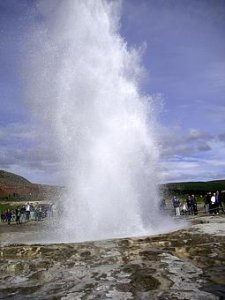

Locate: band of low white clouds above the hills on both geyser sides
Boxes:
[0,119,225,184]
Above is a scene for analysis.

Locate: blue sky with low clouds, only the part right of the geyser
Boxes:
[122,0,225,181]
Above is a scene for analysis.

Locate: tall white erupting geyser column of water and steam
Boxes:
[23,0,177,241]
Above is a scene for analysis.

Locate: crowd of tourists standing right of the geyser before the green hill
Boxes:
[172,191,225,216]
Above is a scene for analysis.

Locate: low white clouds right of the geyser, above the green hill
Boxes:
[160,128,225,182]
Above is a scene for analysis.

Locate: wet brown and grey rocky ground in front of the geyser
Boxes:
[0,215,225,300]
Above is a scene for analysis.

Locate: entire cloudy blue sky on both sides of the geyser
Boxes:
[0,0,225,183]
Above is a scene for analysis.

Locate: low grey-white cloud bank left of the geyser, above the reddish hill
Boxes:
[0,123,61,184]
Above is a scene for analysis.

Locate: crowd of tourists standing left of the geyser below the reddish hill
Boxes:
[0,202,53,225]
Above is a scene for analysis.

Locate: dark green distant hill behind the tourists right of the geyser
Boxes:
[161,180,225,195]
